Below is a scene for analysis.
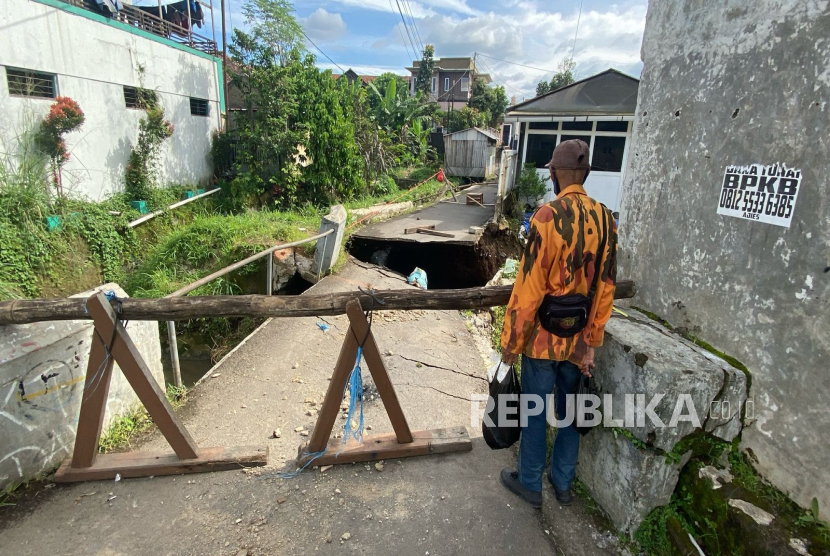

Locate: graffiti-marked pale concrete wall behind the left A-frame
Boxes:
[0,284,164,489]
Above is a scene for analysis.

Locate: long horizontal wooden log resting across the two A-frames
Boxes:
[0,280,637,325]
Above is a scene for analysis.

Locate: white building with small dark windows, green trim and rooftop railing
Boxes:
[0,0,225,200]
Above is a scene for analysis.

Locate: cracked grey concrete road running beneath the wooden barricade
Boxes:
[0,261,624,555]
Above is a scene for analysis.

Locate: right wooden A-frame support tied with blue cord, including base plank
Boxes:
[297,299,473,465]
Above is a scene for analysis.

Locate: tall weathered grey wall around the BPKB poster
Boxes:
[619,0,830,508]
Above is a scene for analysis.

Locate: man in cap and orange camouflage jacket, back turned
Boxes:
[501,139,617,508]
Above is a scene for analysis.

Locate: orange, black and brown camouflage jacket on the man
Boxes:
[501,184,617,365]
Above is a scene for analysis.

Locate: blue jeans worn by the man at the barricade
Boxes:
[518,355,581,492]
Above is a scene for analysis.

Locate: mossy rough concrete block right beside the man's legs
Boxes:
[577,309,747,533]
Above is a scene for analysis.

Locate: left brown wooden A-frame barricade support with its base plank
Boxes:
[55,293,268,482]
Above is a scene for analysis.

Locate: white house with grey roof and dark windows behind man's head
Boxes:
[503,69,640,212]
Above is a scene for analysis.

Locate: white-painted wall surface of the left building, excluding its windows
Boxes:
[0,0,221,200]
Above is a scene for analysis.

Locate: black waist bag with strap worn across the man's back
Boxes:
[536,205,608,338]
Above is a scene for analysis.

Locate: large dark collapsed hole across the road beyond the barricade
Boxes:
[348,226,520,290]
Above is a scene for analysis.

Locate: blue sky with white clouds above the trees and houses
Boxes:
[219,0,647,100]
